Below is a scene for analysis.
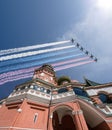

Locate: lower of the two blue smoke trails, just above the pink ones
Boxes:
[0,53,83,73]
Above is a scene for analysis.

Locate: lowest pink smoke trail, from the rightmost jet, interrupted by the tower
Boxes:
[0,61,94,85]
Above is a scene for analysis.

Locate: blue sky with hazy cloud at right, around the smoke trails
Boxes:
[0,0,112,97]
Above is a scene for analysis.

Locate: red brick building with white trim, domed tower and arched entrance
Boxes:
[0,64,112,130]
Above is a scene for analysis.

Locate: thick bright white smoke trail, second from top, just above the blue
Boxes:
[0,45,74,61]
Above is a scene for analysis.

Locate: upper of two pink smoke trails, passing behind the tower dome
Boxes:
[0,57,88,79]
